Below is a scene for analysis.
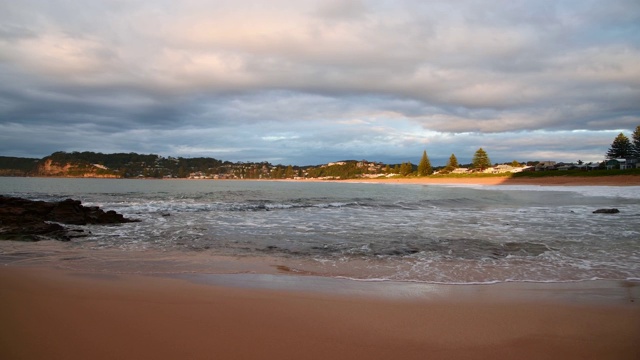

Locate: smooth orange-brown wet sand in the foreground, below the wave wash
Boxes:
[0,266,640,359]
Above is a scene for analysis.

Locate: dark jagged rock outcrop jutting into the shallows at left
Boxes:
[0,195,139,241]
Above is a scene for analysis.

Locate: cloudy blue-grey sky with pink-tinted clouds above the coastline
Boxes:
[0,0,640,165]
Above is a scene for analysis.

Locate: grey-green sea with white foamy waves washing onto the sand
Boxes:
[0,178,640,284]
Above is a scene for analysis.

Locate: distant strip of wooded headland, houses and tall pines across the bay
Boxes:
[0,126,640,180]
